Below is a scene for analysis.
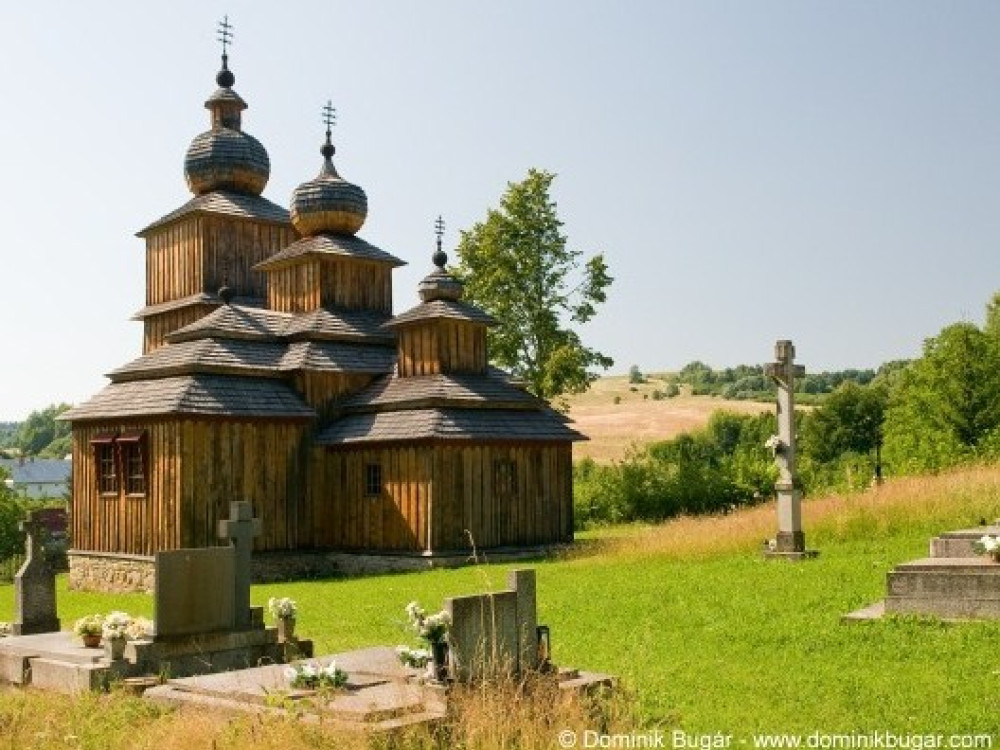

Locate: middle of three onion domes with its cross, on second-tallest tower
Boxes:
[291,103,368,237]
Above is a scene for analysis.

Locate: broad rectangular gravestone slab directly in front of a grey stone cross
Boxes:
[154,547,236,638]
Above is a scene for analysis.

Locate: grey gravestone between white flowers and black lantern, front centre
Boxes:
[444,570,538,682]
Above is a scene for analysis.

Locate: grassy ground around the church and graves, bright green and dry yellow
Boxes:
[0,467,1000,748]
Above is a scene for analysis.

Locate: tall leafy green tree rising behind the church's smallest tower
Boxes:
[455,169,614,398]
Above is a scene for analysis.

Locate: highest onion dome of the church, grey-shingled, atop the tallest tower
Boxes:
[184,52,271,195]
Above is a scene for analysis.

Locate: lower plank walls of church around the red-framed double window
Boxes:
[73,419,305,555]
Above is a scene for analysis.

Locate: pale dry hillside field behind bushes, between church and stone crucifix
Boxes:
[567,376,774,463]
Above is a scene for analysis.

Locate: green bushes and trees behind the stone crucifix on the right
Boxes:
[574,293,1000,526]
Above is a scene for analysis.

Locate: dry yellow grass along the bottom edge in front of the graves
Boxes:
[0,676,636,750]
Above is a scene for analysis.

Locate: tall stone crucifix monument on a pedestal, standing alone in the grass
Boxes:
[764,340,816,559]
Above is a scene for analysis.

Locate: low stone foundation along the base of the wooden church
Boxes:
[69,545,565,594]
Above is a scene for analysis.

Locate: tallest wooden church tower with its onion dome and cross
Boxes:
[134,20,297,354]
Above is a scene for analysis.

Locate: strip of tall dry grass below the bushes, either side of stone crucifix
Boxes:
[602,466,1000,559]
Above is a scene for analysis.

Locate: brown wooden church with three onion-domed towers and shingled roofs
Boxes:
[65,41,582,590]
